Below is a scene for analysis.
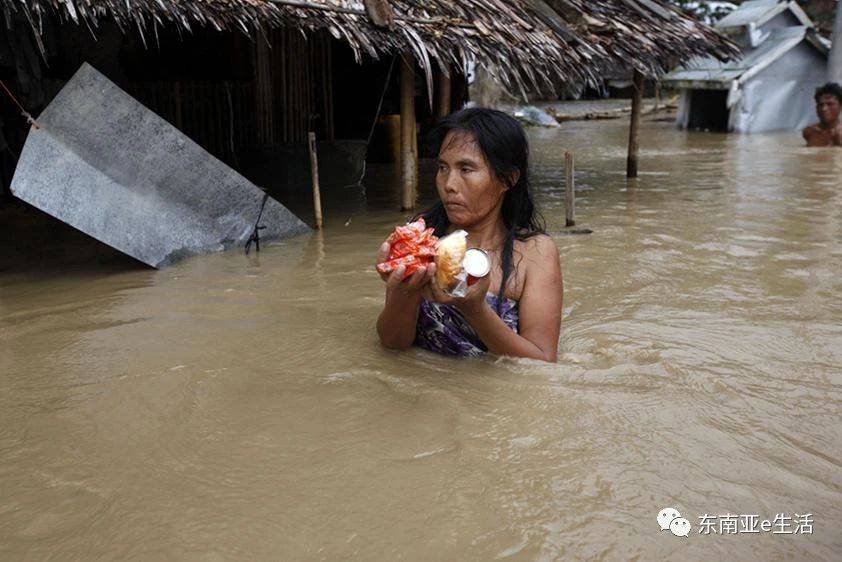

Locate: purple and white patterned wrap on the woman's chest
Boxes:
[415,293,518,357]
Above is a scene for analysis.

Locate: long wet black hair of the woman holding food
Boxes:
[416,107,545,314]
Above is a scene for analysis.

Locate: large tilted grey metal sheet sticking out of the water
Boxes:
[11,64,310,267]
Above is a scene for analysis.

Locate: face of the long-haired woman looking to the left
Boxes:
[436,131,507,228]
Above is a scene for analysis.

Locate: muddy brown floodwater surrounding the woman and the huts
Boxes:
[0,116,842,560]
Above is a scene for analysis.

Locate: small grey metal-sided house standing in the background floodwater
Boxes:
[663,0,829,133]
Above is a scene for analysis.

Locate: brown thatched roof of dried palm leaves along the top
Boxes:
[0,0,734,94]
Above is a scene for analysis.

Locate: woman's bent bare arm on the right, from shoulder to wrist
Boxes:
[454,236,563,362]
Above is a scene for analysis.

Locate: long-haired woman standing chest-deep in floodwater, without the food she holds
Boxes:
[377,108,562,361]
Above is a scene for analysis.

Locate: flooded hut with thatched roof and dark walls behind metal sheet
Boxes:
[0,0,733,224]
